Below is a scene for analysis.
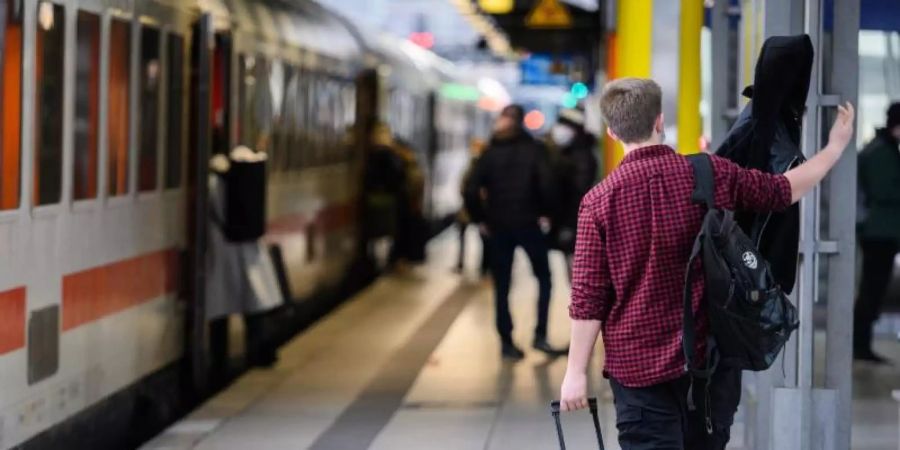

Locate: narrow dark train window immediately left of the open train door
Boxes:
[165,34,185,189]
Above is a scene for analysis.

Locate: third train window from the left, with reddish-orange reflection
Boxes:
[72,11,100,200]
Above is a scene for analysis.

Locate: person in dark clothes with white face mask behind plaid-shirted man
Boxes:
[550,109,598,276]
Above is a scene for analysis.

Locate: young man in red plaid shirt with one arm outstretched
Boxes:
[561,78,854,450]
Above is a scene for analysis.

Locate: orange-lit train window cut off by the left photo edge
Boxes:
[0,2,22,209]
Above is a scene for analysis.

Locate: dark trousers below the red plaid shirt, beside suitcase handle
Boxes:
[610,367,741,450]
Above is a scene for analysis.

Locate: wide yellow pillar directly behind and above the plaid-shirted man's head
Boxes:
[603,0,653,174]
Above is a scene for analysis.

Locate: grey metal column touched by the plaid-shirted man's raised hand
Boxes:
[756,0,859,450]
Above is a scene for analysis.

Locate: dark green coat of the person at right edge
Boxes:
[858,129,900,242]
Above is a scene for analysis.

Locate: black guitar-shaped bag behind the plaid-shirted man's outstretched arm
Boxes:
[716,35,813,293]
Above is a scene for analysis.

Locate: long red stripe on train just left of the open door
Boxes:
[62,249,178,331]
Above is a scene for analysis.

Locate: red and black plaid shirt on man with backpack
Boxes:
[569,146,791,387]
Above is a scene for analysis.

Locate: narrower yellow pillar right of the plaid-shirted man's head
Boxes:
[678,0,703,154]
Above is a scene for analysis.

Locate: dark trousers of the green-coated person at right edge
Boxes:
[853,240,900,353]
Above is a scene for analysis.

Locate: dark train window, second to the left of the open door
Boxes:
[138,26,162,191]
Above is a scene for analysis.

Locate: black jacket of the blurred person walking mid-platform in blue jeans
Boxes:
[465,131,556,230]
